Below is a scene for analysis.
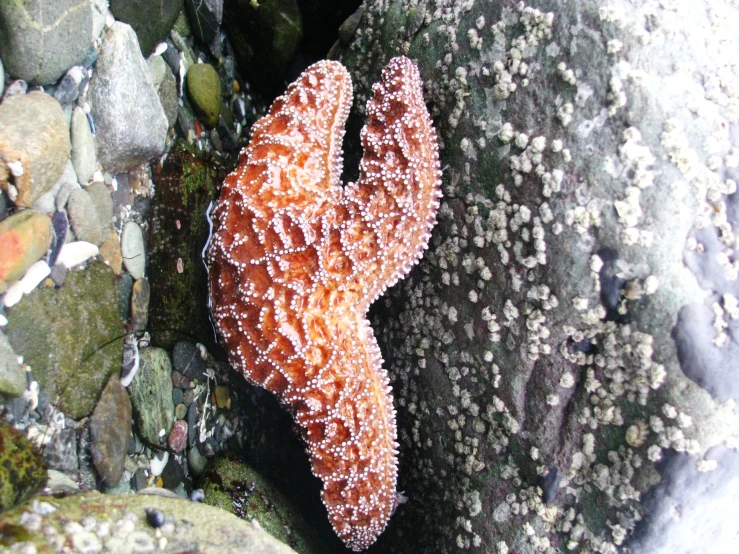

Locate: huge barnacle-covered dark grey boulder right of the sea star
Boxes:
[332,0,739,553]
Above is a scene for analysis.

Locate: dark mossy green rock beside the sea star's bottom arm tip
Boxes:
[203,452,328,554]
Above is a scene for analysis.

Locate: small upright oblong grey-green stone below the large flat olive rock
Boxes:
[128,347,174,444]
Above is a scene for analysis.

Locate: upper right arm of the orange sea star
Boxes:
[342,57,441,307]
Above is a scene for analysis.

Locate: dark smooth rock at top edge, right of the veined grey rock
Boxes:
[110,0,182,56]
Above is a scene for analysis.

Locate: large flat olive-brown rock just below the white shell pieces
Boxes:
[6,262,123,419]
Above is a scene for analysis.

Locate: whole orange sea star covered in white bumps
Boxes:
[208,57,441,550]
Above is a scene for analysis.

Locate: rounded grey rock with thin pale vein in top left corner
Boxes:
[0,0,108,85]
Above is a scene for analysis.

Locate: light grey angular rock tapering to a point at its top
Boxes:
[89,22,168,173]
